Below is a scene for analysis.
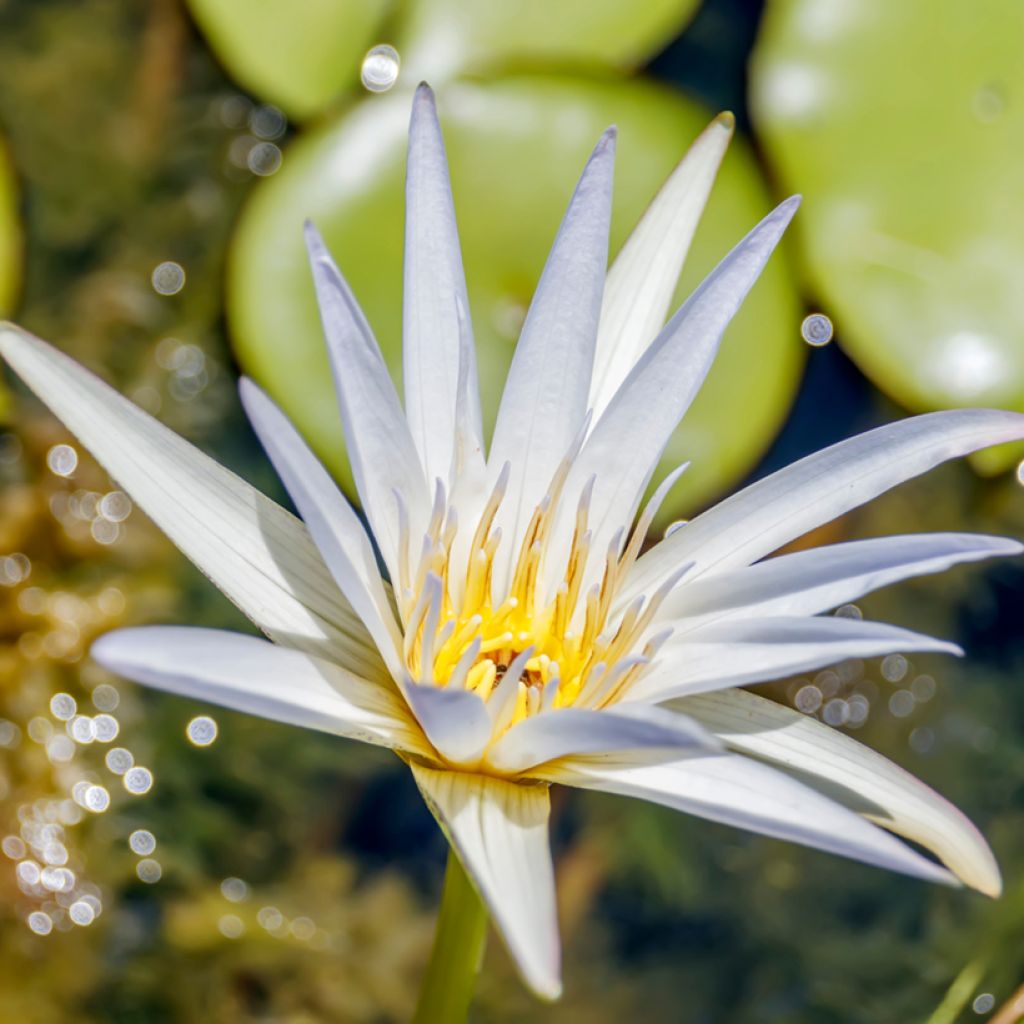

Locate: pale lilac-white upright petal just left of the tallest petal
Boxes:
[306,223,430,580]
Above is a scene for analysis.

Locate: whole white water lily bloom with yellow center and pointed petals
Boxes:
[0,87,1024,997]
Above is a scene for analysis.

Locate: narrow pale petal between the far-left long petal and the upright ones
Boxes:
[239,377,403,679]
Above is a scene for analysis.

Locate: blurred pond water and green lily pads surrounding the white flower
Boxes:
[0,0,1024,1024]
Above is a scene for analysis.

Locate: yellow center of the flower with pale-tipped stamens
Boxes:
[398,461,668,737]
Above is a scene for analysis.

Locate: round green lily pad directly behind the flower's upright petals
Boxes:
[227,77,804,521]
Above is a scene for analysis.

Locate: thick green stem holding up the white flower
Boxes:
[413,849,487,1024]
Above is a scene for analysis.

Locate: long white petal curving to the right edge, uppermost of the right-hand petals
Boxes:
[616,409,1024,607]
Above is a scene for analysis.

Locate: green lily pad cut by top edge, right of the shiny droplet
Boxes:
[396,0,698,84]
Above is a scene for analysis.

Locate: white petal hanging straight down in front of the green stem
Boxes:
[411,763,561,999]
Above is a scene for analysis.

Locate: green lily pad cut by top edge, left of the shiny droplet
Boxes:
[188,0,392,121]
